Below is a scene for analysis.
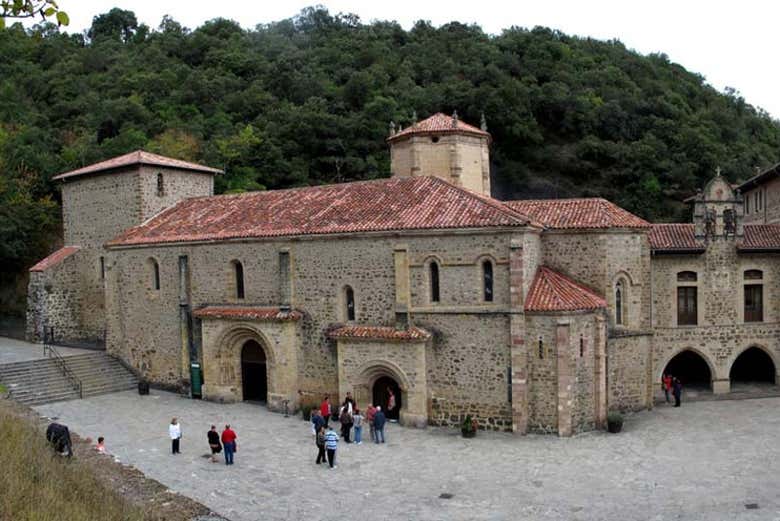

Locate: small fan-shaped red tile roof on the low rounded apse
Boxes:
[525,266,607,312]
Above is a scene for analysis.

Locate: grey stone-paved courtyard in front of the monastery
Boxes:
[36,391,780,521]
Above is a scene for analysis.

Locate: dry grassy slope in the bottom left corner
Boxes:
[0,400,143,521]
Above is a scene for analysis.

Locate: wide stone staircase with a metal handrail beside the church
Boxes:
[0,351,138,405]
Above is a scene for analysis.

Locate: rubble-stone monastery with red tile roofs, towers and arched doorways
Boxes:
[28,114,780,436]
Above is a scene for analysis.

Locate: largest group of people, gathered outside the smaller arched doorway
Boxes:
[311,389,395,469]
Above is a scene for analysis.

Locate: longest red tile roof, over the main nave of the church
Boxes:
[108,176,529,246]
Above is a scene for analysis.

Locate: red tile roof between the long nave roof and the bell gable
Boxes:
[504,198,650,229]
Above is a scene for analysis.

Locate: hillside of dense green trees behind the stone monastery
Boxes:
[0,4,780,310]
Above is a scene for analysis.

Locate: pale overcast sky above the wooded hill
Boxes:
[44,0,780,119]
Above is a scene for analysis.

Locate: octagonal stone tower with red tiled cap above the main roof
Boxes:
[387,112,491,197]
